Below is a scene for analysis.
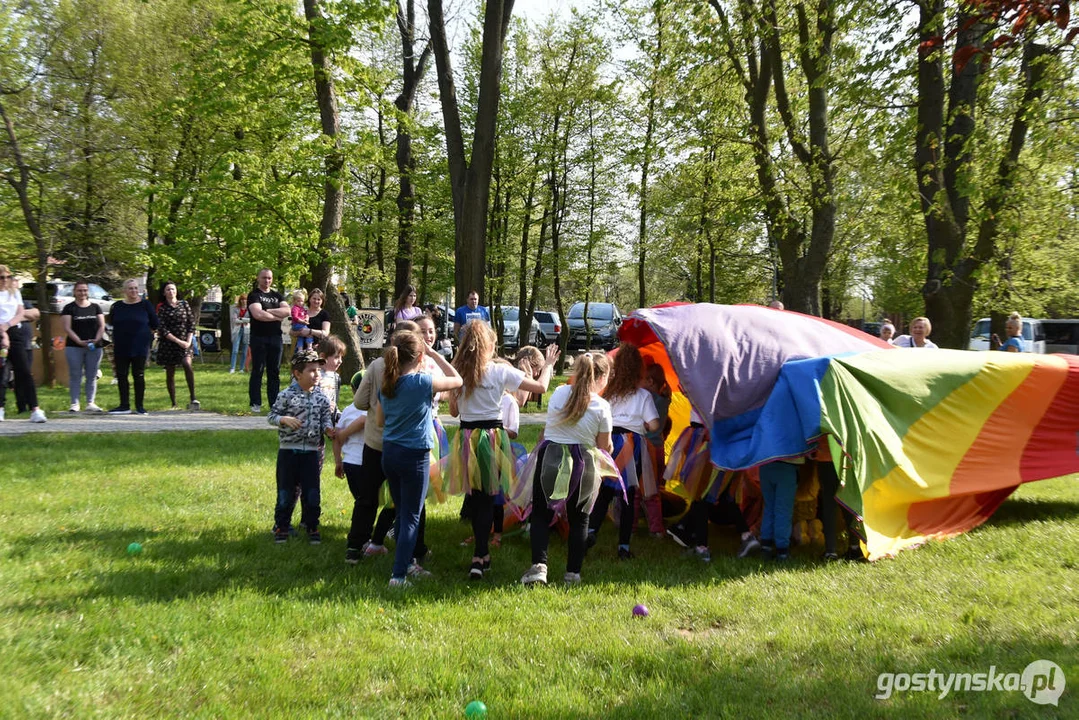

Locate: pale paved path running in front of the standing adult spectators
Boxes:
[0,410,547,437]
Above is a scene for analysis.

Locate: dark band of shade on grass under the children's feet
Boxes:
[9,518,837,610]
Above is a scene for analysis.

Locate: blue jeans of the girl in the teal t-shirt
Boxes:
[382,443,431,578]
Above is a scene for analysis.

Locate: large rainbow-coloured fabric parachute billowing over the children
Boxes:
[633,305,1079,559]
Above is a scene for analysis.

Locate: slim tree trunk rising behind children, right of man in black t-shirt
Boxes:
[303,0,364,378]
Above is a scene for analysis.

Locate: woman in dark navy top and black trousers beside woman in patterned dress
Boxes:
[109,279,160,415]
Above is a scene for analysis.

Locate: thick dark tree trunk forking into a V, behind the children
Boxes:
[427,0,514,305]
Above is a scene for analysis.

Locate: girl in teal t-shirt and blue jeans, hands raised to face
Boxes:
[374,330,461,587]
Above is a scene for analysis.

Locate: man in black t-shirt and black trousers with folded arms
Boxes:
[247,268,289,412]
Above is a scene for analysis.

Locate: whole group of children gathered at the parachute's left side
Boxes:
[269,316,867,586]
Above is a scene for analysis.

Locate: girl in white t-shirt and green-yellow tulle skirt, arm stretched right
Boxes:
[449,323,558,580]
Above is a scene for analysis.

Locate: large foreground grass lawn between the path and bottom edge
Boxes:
[0,431,1079,719]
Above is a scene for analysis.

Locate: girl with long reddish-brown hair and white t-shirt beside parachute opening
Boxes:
[587,342,659,560]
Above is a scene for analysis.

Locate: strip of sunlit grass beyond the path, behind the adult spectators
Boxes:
[25,350,565,418]
